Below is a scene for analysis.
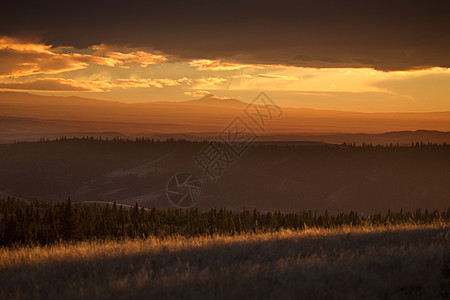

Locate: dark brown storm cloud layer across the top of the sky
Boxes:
[0,0,450,71]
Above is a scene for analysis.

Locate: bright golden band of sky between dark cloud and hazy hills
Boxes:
[0,37,450,111]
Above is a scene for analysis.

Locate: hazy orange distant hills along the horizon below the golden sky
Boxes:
[0,92,450,143]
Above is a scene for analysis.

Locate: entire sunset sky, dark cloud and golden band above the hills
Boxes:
[0,1,450,112]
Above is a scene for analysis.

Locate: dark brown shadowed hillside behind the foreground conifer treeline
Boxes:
[0,139,450,213]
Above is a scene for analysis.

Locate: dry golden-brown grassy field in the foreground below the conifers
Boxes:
[0,224,450,299]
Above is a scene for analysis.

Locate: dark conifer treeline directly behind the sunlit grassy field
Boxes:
[0,198,450,246]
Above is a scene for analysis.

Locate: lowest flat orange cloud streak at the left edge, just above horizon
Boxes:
[0,78,113,92]
